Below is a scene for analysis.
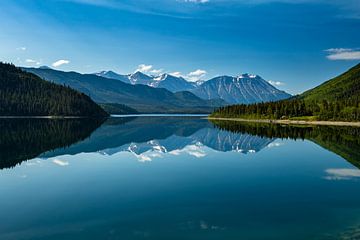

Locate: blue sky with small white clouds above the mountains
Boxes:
[0,0,360,93]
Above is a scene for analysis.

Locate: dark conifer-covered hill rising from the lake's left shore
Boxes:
[0,63,107,117]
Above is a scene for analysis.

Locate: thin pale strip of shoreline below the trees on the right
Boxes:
[207,117,360,127]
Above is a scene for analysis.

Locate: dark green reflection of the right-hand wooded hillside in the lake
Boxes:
[212,120,360,167]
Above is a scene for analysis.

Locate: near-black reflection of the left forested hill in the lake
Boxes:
[0,118,104,169]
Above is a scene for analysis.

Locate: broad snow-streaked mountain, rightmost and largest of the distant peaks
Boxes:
[191,74,291,104]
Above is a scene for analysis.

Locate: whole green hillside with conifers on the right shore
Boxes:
[211,64,360,121]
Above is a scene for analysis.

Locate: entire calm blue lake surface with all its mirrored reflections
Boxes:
[0,116,360,240]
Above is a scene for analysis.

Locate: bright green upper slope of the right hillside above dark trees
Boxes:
[300,63,360,102]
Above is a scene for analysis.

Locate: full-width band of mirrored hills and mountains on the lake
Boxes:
[0,116,360,168]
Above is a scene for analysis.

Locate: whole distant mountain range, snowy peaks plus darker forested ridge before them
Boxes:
[23,67,291,113]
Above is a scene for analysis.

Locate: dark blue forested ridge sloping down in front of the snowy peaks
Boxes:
[23,68,226,113]
